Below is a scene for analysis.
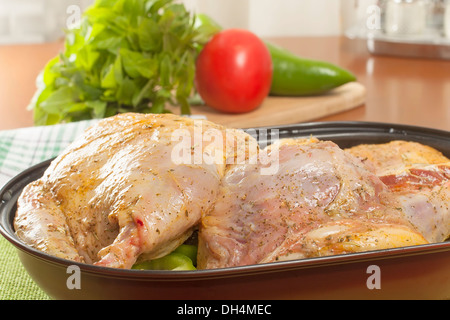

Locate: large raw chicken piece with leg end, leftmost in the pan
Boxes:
[15,114,256,268]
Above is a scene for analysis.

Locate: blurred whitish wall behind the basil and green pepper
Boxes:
[0,0,370,44]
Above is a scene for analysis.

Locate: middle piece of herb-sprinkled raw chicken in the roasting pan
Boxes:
[198,139,427,269]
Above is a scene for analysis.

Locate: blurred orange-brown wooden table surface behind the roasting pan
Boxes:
[0,36,450,130]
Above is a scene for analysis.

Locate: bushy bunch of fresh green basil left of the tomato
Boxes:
[30,0,217,125]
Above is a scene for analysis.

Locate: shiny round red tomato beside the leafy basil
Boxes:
[195,29,272,113]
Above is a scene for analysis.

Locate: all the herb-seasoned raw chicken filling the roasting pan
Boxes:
[14,113,450,269]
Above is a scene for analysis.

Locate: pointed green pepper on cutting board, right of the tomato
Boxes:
[266,42,356,96]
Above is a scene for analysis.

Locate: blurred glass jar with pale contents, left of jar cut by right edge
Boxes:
[384,0,429,36]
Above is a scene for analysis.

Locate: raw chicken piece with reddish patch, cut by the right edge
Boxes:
[347,141,450,242]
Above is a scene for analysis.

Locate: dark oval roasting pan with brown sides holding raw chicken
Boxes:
[0,122,450,300]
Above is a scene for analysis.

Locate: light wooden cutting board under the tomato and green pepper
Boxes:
[183,82,366,128]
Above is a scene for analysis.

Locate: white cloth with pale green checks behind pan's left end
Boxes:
[0,120,98,187]
